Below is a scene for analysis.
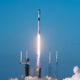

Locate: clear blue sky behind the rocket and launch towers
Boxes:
[0,0,80,80]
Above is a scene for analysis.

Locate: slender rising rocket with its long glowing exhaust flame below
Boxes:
[36,9,41,78]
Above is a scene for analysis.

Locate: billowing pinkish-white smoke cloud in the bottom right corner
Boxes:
[63,66,80,80]
